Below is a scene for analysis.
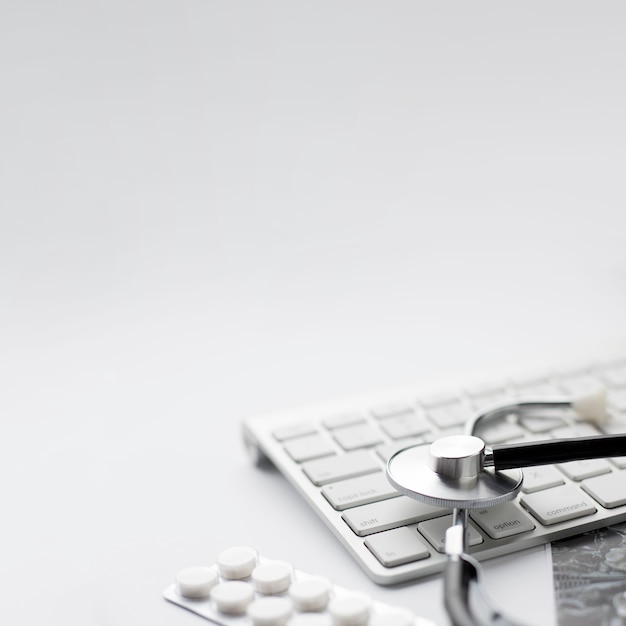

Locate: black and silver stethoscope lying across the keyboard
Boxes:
[387,389,626,626]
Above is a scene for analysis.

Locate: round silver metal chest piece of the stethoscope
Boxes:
[387,435,523,509]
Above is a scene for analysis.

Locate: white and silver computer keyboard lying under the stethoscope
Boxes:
[244,348,626,585]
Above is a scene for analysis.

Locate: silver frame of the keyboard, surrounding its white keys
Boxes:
[243,341,626,585]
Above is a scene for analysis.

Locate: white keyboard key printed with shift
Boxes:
[342,496,447,537]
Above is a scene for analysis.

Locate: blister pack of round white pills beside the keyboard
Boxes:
[163,546,435,626]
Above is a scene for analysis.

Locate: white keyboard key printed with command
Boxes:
[520,485,598,526]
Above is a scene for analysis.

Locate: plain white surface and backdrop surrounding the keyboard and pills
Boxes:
[0,0,626,626]
